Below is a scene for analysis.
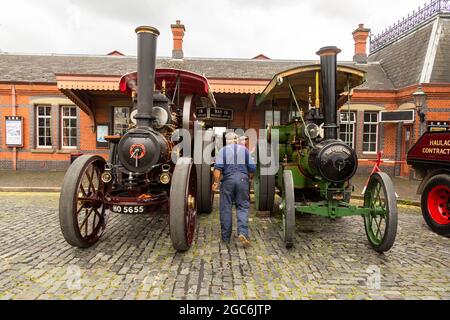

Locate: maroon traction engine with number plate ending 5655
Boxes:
[59,26,215,251]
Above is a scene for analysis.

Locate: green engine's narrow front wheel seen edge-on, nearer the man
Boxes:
[282,170,295,249]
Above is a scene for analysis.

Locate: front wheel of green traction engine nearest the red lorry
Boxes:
[364,172,397,252]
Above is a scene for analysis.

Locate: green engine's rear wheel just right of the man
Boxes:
[253,142,275,212]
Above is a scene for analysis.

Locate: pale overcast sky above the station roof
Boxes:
[0,0,429,60]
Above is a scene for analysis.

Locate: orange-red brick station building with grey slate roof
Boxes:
[0,0,450,176]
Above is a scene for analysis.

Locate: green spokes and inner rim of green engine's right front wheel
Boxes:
[364,179,389,246]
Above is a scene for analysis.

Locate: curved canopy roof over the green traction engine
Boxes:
[256,64,366,106]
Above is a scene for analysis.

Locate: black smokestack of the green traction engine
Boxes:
[317,47,341,140]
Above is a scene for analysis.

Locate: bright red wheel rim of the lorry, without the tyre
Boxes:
[427,186,450,225]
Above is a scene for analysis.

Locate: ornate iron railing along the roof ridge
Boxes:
[370,0,450,53]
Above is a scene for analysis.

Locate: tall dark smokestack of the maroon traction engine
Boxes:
[135,26,159,127]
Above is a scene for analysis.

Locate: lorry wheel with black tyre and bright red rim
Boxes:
[421,174,450,237]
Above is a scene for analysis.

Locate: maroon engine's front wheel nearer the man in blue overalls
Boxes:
[169,158,197,251]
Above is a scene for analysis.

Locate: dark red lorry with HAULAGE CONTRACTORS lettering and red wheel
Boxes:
[407,131,450,237]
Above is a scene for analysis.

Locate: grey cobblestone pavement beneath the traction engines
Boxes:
[0,193,450,299]
